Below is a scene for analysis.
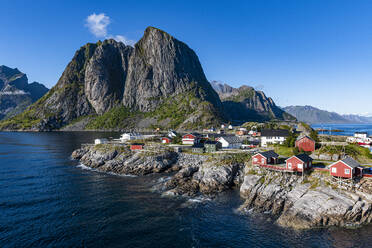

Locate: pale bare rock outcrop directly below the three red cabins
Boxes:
[240,169,372,229]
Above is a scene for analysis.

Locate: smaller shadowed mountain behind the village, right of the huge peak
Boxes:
[211,81,295,122]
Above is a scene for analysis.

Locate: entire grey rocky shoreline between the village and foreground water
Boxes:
[72,144,372,229]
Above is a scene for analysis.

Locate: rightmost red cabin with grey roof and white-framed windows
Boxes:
[329,157,363,178]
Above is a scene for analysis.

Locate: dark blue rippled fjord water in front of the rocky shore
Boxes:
[0,132,372,247]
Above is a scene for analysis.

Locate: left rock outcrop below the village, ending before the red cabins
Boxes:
[71,145,244,196]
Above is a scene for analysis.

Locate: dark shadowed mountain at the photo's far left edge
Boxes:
[0,65,48,119]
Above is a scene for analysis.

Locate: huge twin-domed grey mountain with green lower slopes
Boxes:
[0,27,223,131]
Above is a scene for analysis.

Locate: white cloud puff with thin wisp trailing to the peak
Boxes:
[85,13,136,46]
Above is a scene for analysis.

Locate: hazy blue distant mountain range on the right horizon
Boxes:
[283,106,372,124]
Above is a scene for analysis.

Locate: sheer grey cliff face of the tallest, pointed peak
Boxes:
[123,27,221,112]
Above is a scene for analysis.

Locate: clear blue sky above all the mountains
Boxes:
[0,0,372,113]
